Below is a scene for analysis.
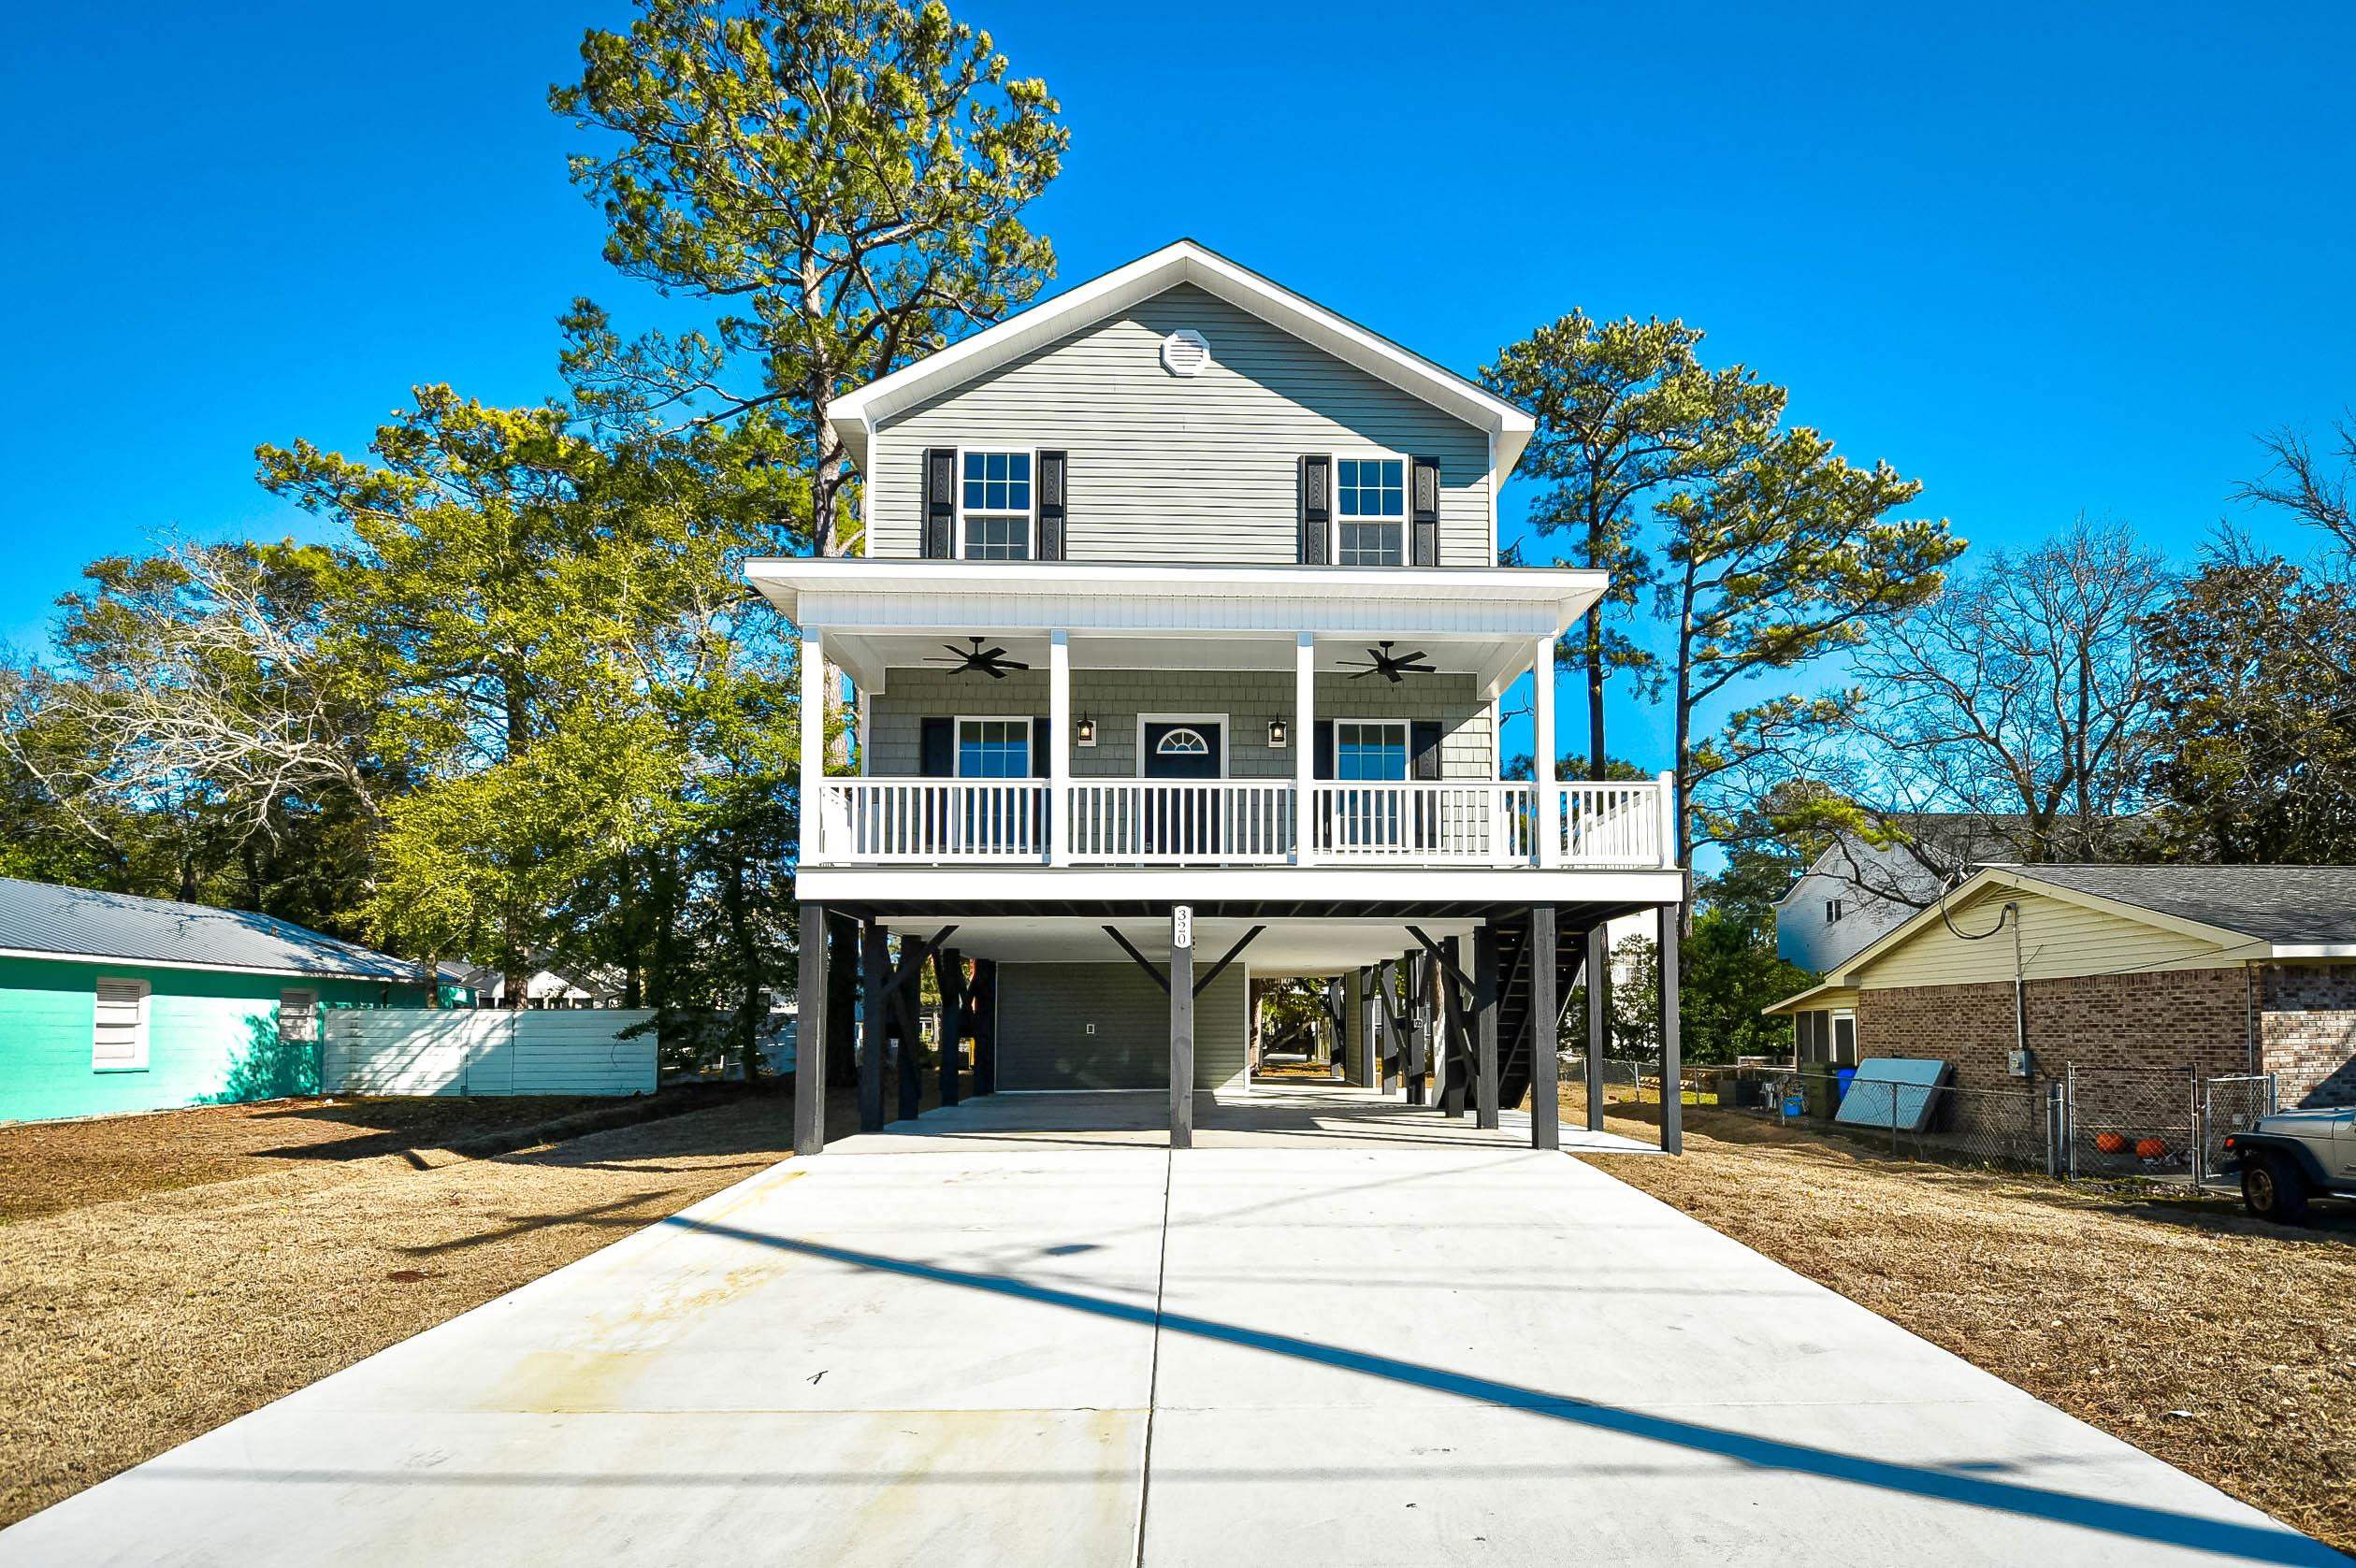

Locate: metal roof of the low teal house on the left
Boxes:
[0,876,424,979]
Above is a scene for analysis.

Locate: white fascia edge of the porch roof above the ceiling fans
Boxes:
[744,555,1609,636]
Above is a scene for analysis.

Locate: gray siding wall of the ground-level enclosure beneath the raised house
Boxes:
[999,954,1247,1090]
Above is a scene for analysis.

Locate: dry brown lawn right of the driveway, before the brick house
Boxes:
[1565,1097,2356,1551]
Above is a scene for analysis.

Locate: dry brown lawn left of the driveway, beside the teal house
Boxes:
[0,1095,829,1523]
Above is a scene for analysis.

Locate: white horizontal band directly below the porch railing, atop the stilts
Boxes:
[794,867,1684,899]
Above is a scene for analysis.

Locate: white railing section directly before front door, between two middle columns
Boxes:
[1070,779,1294,867]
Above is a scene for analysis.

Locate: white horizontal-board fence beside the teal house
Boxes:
[321,1008,655,1095]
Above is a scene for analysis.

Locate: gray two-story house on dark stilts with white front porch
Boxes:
[749,240,1684,1154]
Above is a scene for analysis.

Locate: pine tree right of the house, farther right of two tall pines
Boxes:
[1656,428,1962,864]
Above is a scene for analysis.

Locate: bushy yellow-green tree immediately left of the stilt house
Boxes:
[262,388,801,1064]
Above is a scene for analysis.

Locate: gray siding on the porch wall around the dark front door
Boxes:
[867,669,1496,779]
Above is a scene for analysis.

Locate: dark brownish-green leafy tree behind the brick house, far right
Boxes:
[2142,541,2356,864]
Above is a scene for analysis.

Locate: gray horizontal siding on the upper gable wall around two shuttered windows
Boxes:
[867,285,1494,565]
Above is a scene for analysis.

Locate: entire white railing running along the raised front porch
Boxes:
[805,777,1672,869]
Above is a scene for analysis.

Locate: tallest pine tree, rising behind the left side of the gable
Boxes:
[549,0,1067,554]
